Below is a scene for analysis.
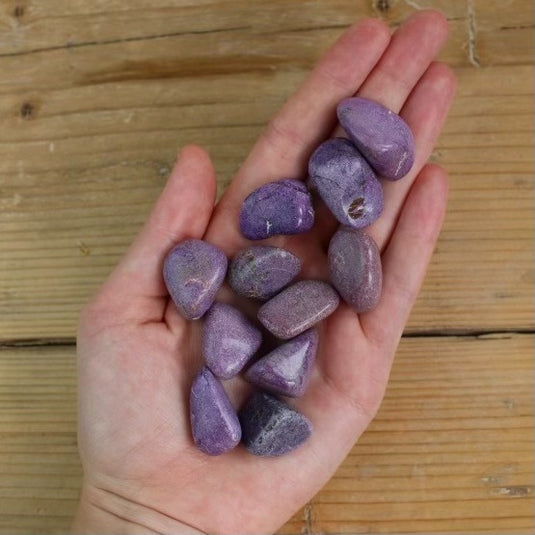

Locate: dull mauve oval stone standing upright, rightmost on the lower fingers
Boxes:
[328,227,383,312]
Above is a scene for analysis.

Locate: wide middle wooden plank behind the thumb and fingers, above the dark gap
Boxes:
[0,60,533,340]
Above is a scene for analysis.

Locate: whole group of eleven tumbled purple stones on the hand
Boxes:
[163,97,414,456]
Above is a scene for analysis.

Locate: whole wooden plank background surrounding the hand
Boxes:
[0,0,535,534]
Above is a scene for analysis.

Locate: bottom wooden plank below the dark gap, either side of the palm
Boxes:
[0,335,534,534]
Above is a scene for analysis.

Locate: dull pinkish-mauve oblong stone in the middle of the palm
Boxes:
[258,280,340,339]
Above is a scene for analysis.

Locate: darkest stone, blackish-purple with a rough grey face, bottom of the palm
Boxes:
[239,392,312,457]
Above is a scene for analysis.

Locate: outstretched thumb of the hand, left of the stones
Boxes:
[97,145,216,321]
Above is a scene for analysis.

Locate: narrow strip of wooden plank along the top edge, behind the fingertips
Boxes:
[0,0,533,65]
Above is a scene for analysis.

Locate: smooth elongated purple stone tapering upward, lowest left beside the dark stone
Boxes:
[190,367,241,455]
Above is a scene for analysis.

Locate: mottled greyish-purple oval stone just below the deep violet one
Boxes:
[228,245,301,299]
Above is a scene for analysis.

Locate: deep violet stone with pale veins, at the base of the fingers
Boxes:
[240,179,314,240]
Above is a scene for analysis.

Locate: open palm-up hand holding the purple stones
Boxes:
[73,11,455,533]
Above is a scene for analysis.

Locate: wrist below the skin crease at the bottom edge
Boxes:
[71,484,203,535]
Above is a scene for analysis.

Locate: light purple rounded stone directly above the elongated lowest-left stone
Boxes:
[202,303,262,379]
